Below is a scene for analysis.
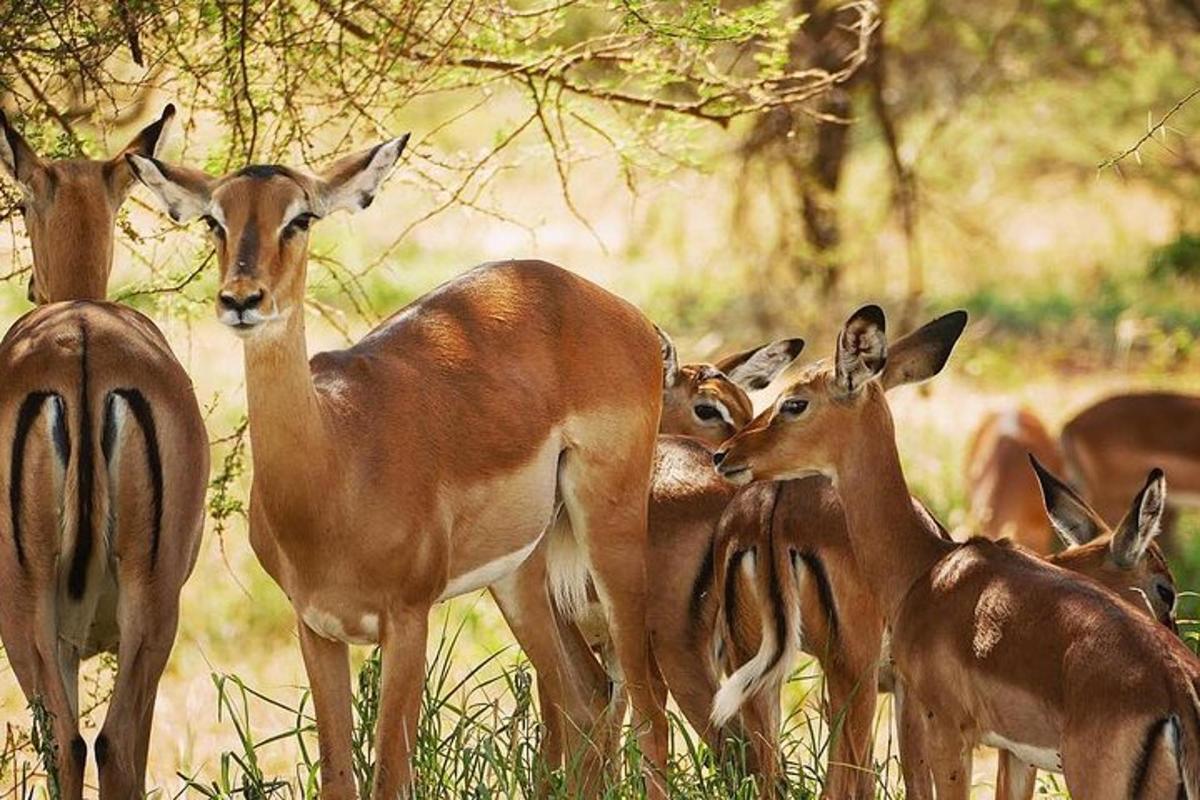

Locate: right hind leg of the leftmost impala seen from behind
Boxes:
[96,581,179,800]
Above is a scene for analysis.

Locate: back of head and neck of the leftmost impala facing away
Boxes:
[0,104,175,303]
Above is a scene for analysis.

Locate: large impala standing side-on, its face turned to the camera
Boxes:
[131,137,667,800]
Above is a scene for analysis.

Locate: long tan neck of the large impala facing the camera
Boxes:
[245,307,330,512]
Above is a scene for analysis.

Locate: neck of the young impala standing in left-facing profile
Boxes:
[836,398,954,621]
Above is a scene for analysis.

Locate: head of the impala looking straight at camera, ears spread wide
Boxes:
[128,133,408,335]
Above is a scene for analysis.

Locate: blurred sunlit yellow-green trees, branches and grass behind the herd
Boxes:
[0,0,1200,793]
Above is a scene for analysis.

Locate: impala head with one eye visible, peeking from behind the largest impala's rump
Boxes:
[659,330,804,447]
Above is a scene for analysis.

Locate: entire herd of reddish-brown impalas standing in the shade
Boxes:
[0,106,1200,800]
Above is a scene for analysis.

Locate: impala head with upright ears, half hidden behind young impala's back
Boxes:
[1030,456,1176,631]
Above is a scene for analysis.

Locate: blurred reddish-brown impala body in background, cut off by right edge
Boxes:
[1061,392,1200,551]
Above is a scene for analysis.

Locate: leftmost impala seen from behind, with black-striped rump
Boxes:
[0,106,209,799]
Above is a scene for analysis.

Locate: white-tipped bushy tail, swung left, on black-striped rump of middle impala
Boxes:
[712,487,803,727]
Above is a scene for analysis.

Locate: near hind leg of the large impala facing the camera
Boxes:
[559,441,668,798]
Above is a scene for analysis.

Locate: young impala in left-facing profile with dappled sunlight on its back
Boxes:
[714,306,1200,800]
